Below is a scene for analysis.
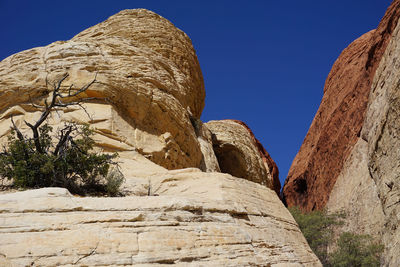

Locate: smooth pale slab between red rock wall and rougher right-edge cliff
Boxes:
[326,138,385,240]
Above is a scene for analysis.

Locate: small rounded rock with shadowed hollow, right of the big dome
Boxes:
[206,120,281,195]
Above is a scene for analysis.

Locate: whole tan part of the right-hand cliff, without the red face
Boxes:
[326,16,400,266]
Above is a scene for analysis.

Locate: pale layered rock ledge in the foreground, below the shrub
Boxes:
[0,169,321,266]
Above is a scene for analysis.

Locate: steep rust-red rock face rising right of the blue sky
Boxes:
[283,0,400,211]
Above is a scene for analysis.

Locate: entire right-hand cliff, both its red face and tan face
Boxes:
[283,0,400,266]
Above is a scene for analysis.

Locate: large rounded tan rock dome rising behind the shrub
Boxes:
[0,9,205,172]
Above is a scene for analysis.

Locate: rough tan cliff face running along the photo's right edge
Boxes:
[362,16,400,266]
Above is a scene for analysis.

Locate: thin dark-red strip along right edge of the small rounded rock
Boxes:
[231,120,281,196]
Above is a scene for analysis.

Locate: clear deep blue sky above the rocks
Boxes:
[0,0,391,188]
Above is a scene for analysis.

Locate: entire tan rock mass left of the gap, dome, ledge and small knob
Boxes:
[0,9,321,266]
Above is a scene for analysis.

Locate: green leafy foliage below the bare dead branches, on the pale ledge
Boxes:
[0,124,123,195]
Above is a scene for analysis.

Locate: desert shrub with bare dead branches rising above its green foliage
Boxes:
[0,74,124,195]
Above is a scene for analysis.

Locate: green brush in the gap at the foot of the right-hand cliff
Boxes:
[289,207,383,267]
